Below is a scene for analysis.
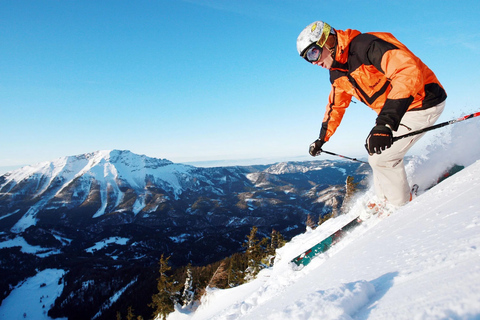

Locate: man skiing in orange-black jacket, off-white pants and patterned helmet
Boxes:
[297,21,447,206]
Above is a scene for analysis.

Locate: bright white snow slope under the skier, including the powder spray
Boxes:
[168,121,480,320]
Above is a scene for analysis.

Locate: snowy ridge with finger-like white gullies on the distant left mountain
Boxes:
[0,150,206,232]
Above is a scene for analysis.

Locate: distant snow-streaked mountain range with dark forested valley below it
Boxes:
[0,150,369,319]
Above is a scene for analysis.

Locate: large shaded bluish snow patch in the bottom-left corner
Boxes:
[0,269,65,320]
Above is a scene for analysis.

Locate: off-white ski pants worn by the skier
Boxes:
[368,101,445,206]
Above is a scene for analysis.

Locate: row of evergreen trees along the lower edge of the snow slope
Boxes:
[117,226,285,320]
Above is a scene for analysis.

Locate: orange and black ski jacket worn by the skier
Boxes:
[320,29,447,141]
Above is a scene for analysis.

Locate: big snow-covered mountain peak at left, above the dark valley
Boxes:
[0,150,235,232]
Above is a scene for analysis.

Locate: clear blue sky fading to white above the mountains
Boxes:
[0,0,480,172]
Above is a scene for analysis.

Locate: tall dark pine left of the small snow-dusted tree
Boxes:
[148,254,176,320]
